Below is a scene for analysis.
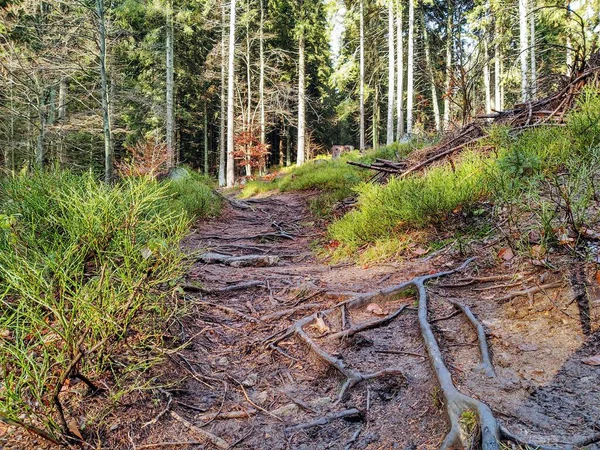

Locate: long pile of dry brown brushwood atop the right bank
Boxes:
[348,52,600,182]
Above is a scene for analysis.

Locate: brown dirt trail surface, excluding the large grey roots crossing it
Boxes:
[143,194,600,450]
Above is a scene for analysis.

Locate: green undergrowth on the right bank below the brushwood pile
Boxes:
[329,88,600,260]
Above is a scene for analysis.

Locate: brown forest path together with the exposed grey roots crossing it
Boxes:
[144,194,600,450]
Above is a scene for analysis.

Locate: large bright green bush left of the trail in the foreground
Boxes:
[0,172,189,436]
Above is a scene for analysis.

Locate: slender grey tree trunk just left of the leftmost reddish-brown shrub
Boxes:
[96,0,113,183]
